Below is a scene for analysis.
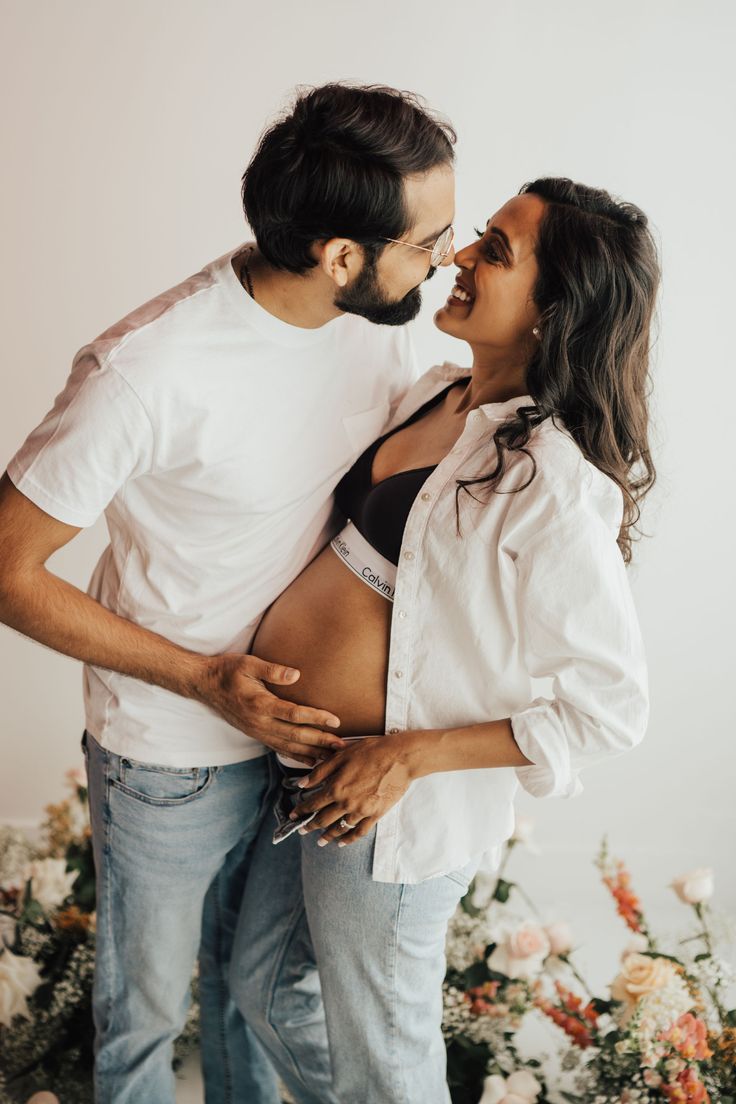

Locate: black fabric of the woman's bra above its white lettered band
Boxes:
[334,378,467,564]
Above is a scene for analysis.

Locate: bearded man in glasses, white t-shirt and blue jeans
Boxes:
[0,84,455,1104]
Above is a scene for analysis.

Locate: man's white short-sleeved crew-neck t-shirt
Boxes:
[8,246,415,766]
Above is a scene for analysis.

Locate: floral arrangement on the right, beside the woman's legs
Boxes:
[444,817,736,1104]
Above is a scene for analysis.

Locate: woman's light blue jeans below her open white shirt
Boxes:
[231,799,477,1104]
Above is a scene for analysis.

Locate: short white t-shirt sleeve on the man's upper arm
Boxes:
[8,349,153,528]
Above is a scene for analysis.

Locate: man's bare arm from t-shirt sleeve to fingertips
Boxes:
[0,473,344,762]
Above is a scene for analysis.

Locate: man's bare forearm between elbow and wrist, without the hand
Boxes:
[0,566,207,698]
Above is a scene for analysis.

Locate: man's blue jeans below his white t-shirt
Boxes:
[83,733,279,1104]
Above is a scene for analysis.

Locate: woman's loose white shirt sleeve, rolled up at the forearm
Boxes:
[511,507,649,797]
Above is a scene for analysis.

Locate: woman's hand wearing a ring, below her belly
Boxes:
[292,733,415,847]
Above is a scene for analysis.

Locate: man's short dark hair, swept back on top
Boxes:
[243,83,456,273]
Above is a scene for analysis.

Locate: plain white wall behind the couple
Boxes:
[0,0,736,989]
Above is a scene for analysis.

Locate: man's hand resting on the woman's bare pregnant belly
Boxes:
[195,654,345,766]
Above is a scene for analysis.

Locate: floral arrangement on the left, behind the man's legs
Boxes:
[0,771,198,1104]
